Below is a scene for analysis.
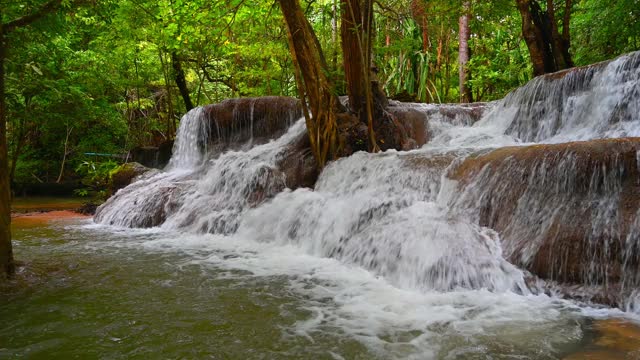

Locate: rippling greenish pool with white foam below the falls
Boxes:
[5,220,640,359]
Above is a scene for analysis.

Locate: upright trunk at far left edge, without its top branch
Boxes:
[0,31,14,277]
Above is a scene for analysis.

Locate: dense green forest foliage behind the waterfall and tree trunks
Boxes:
[1,0,640,190]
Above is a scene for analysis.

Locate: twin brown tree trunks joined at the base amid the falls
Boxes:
[278,0,407,168]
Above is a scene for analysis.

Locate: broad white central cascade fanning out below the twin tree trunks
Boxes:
[239,153,526,292]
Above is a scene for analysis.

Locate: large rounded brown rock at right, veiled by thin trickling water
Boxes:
[449,138,640,307]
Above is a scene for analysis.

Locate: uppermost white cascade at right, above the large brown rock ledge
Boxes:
[430,52,640,148]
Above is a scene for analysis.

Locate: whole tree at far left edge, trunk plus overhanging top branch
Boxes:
[0,0,75,276]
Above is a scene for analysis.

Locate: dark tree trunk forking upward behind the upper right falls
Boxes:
[516,0,573,76]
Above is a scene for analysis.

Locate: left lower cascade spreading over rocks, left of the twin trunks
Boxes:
[94,116,304,233]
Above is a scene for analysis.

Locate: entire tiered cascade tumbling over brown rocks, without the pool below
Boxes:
[95,53,640,309]
